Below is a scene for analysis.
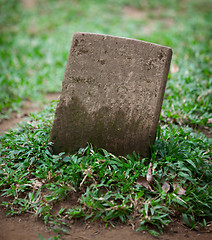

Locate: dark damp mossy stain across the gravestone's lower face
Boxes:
[50,97,152,156]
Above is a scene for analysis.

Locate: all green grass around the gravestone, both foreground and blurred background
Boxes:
[0,0,212,238]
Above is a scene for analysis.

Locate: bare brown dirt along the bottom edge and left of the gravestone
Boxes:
[0,93,212,240]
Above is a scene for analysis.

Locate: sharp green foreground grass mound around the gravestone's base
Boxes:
[0,104,212,235]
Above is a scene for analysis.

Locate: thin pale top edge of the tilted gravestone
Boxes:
[73,32,173,54]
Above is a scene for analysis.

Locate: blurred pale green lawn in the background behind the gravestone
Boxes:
[0,0,212,127]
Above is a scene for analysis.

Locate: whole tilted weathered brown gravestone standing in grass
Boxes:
[50,33,172,156]
